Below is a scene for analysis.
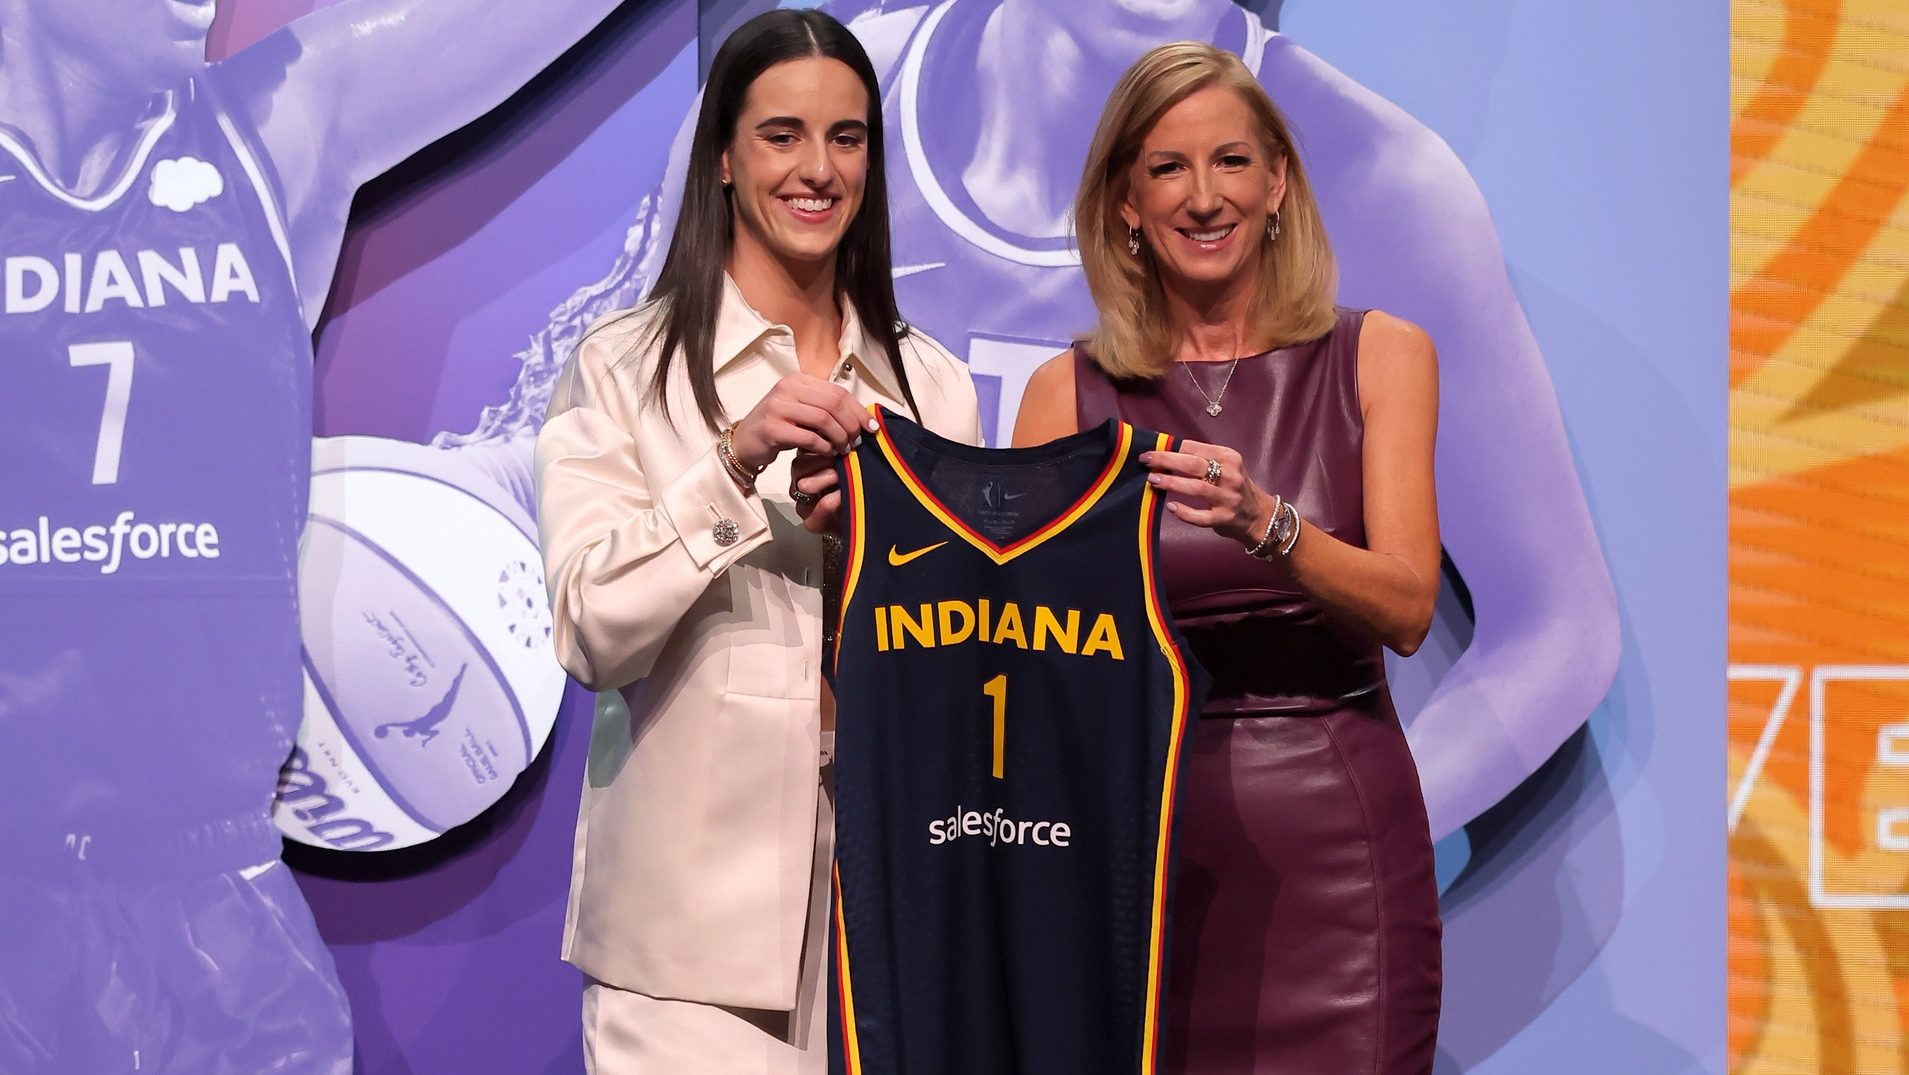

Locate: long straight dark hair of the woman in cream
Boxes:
[649,10,920,430]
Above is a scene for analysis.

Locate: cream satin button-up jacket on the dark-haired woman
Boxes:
[536,277,981,1010]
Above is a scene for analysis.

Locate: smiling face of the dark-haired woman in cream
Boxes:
[722,57,869,274]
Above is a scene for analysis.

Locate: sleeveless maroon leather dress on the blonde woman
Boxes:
[1075,309,1439,1075]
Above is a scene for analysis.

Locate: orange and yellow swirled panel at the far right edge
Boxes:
[1730,0,1909,1075]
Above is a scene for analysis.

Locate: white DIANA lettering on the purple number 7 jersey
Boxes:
[0,242,260,313]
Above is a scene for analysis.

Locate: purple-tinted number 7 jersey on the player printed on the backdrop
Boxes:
[0,73,311,865]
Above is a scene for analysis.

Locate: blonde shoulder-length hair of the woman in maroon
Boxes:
[1075,42,1338,378]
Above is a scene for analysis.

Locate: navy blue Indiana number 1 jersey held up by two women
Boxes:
[830,412,1205,1075]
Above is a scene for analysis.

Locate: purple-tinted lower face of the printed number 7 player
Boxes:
[21,0,216,90]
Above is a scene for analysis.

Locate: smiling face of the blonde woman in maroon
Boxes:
[1121,86,1287,301]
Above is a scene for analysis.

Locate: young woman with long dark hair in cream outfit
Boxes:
[536,10,979,1073]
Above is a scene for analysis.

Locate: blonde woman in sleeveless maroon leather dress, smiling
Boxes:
[1014,42,1439,1075]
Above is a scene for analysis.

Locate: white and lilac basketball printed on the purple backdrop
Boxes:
[275,437,565,852]
